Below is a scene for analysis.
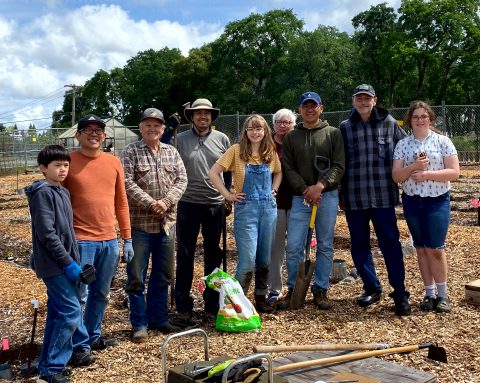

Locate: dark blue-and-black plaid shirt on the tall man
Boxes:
[340,107,406,210]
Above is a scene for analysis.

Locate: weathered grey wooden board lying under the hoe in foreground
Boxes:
[273,351,437,383]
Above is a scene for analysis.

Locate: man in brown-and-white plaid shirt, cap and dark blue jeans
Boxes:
[121,108,187,343]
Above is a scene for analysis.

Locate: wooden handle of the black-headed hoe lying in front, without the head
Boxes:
[273,345,420,372]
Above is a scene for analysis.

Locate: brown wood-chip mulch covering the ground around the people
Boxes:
[0,172,480,383]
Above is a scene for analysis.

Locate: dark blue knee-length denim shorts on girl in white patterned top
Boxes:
[402,192,450,249]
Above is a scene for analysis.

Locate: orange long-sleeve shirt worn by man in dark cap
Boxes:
[64,152,132,241]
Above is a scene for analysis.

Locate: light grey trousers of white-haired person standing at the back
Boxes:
[268,209,290,294]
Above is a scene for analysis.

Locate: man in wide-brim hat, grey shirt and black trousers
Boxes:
[175,98,230,327]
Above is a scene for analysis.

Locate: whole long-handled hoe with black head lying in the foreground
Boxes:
[273,343,447,372]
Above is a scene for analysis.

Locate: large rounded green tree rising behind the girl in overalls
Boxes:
[210,10,303,113]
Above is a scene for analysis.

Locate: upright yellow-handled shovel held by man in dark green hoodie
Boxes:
[290,205,318,310]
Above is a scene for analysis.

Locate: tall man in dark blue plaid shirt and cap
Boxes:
[340,84,411,316]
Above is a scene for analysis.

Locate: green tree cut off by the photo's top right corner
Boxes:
[400,0,480,103]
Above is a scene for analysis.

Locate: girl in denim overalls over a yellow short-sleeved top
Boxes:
[209,114,282,312]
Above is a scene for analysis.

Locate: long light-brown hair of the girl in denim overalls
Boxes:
[238,114,275,163]
